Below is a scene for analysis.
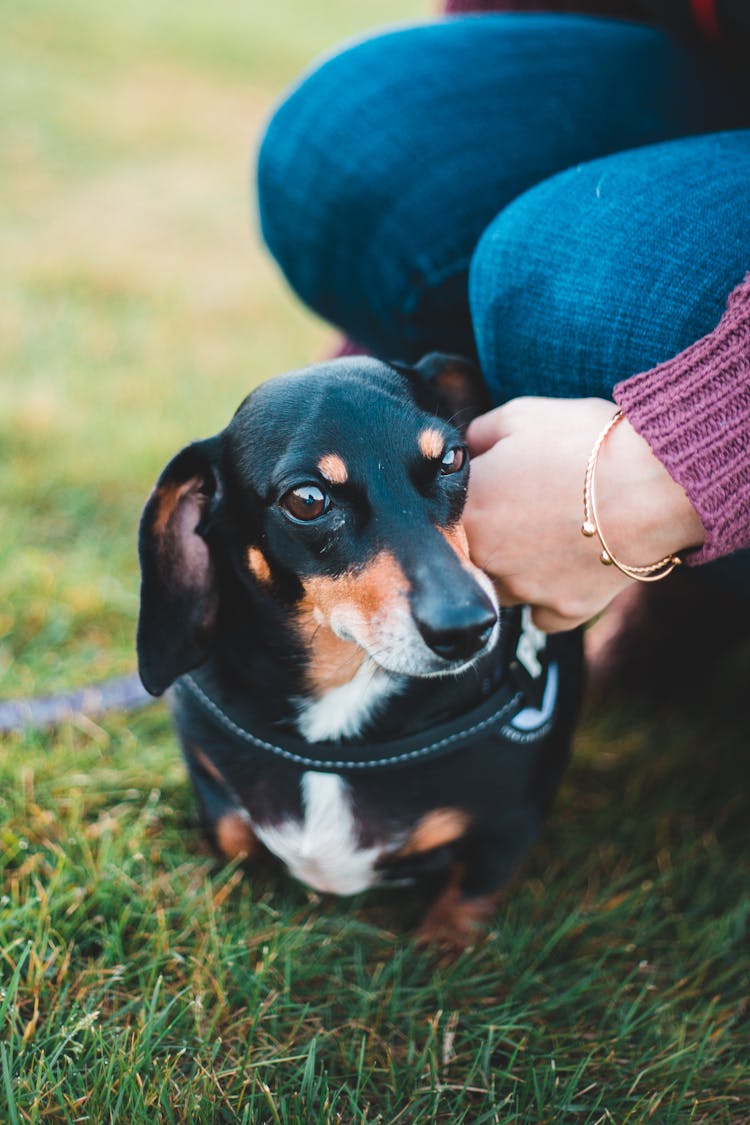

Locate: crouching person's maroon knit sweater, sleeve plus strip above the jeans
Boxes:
[445,0,750,565]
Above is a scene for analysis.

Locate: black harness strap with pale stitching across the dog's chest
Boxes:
[173,606,560,773]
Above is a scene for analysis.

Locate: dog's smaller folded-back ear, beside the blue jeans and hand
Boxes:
[392,352,491,433]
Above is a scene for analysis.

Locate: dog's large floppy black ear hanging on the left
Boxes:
[137,438,223,695]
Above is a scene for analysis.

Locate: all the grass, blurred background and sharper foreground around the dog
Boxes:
[0,0,750,1125]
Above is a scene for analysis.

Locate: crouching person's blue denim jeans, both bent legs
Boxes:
[257,14,750,589]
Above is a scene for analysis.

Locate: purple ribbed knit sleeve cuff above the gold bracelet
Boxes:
[613,275,750,565]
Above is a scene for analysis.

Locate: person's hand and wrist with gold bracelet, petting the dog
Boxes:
[463,398,704,632]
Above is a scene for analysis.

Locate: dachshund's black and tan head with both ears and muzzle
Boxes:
[138,356,497,694]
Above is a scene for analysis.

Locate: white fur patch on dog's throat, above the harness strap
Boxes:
[297,659,399,743]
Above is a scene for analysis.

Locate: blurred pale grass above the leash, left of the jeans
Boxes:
[0,0,425,696]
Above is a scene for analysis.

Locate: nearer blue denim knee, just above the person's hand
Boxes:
[469,131,750,402]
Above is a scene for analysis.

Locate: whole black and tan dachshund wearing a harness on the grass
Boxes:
[138,356,580,947]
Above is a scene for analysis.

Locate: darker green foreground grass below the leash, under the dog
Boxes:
[0,693,750,1125]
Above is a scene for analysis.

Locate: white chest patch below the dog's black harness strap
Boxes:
[253,771,383,894]
